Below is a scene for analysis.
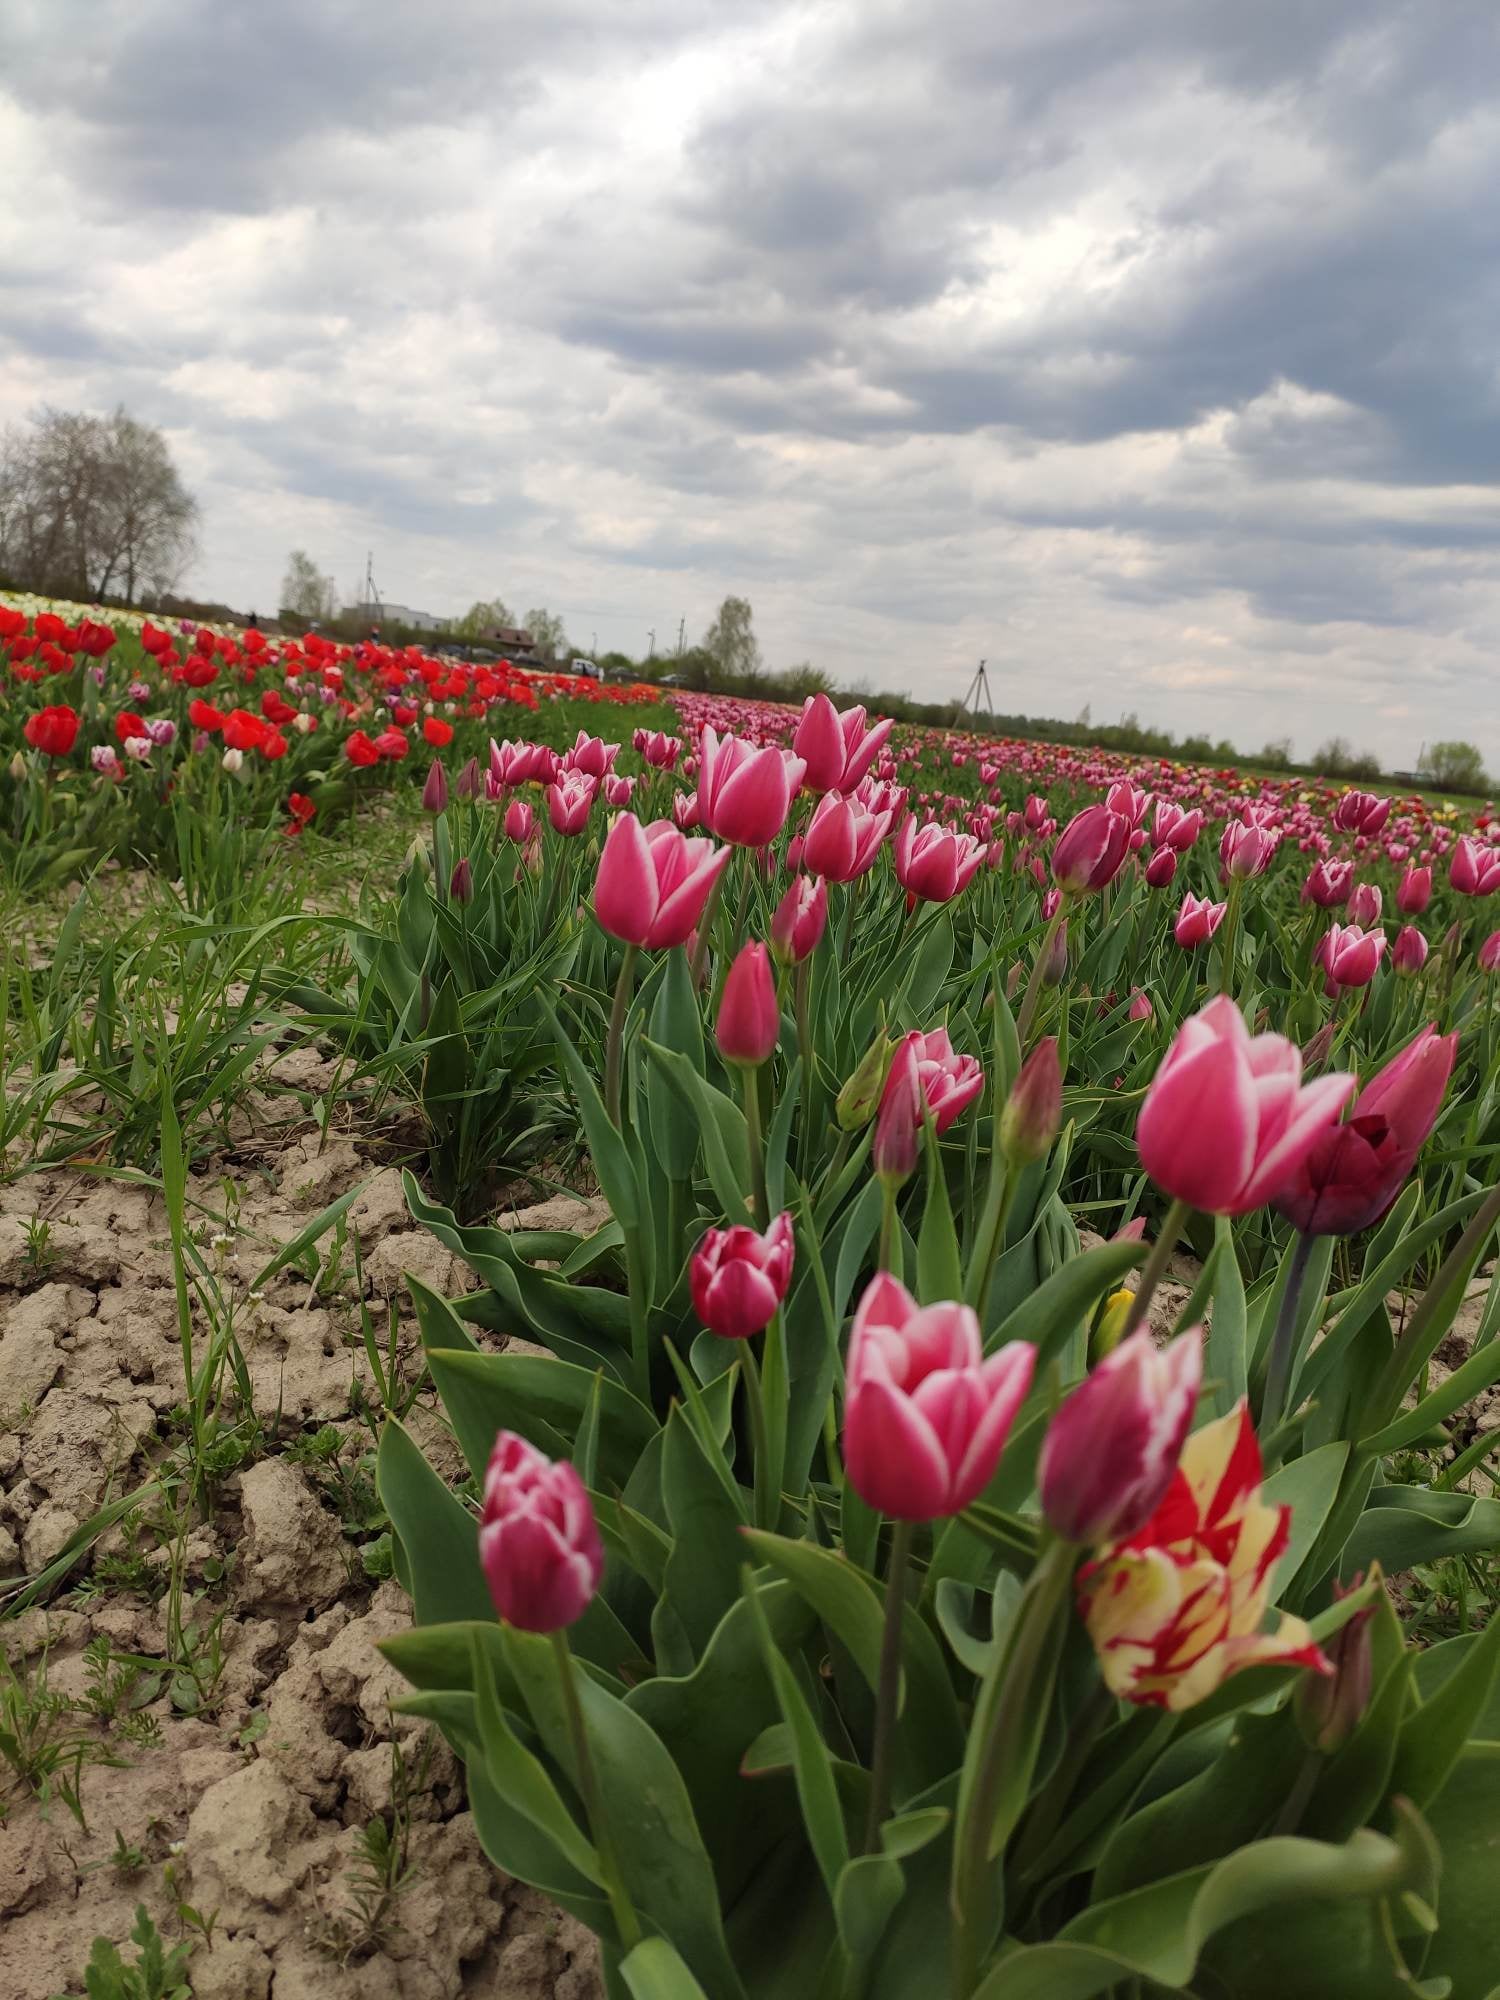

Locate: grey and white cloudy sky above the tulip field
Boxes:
[0,0,1500,768]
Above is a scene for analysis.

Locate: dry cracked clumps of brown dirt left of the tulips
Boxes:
[0,1112,602,2000]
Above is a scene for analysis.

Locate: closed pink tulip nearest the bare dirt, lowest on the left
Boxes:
[480,1430,604,1632]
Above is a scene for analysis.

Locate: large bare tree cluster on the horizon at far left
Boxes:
[0,408,198,604]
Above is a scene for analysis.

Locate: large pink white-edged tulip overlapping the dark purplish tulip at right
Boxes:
[1136,994,1354,1216]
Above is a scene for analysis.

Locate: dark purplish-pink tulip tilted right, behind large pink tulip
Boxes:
[1274,1028,1458,1236]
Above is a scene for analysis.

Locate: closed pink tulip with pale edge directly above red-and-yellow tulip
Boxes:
[1038,1326,1204,1542]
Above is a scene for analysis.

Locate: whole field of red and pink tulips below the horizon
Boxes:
[0,584,1500,2000]
